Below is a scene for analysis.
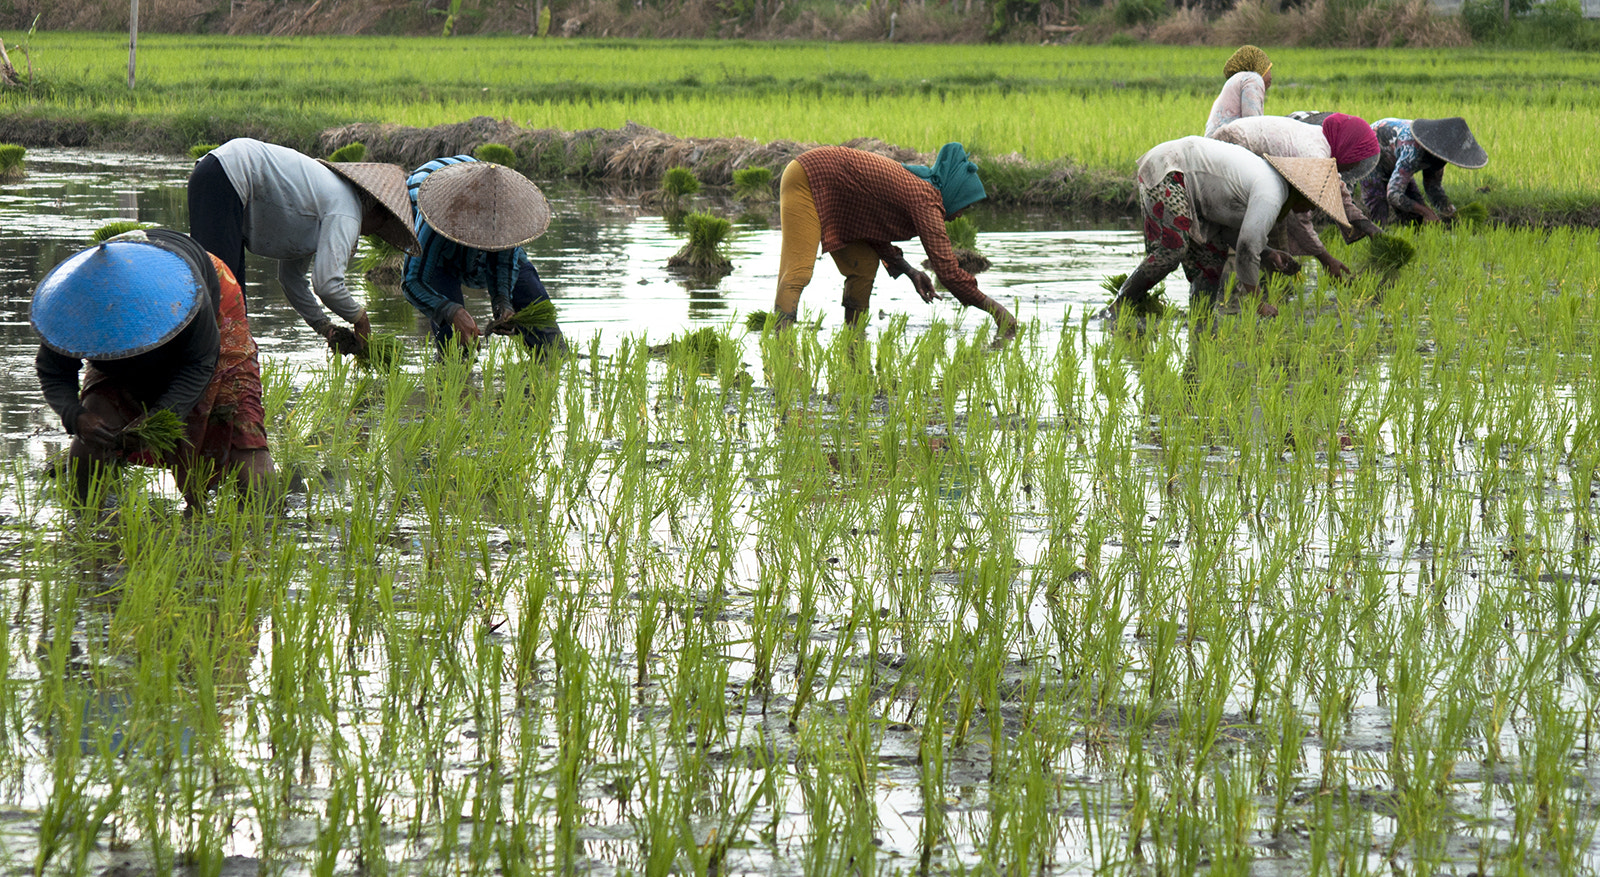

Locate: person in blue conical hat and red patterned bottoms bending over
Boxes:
[29,229,274,507]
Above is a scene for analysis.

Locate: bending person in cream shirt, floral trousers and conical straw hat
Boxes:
[1110,134,1344,317]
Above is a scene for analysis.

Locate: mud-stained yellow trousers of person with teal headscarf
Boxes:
[773,162,878,318]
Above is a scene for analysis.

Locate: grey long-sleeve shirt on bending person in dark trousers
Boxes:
[211,138,362,330]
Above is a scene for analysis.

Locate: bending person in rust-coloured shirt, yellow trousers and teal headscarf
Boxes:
[774,142,1016,338]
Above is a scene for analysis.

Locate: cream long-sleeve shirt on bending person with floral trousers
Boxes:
[1139,138,1290,286]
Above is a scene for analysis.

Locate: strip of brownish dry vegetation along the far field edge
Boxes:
[0,0,1600,48]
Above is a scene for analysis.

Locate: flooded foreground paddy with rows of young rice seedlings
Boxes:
[0,150,1600,874]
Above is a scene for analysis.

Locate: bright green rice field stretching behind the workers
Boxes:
[9,34,1600,219]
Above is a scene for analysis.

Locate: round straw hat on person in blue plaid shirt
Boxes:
[416,162,550,251]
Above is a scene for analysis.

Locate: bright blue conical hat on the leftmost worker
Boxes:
[29,240,206,360]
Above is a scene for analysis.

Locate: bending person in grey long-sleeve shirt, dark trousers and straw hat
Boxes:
[189,138,416,350]
